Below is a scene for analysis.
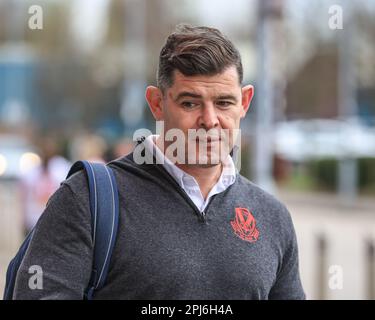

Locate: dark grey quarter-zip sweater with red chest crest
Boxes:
[13,148,305,300]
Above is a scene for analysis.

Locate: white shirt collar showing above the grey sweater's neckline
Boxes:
[145,135,236,212]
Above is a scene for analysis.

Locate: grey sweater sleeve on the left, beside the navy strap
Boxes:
[13,183,92,299]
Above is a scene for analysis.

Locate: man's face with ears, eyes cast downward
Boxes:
[146,66,253,165]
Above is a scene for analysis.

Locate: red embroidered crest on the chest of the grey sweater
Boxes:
[230,208,259,242]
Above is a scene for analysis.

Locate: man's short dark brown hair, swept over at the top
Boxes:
[157,24,243,90]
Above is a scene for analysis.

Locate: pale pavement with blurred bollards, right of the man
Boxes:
[278,192,375,300]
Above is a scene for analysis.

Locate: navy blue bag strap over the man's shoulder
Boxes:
[67,161,119,300]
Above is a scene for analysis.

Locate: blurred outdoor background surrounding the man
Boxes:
[0,0,375,299]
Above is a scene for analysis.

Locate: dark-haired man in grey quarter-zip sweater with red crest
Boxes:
[14,25,305,299]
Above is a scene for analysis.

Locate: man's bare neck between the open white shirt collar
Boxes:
[156,136,223,199]
